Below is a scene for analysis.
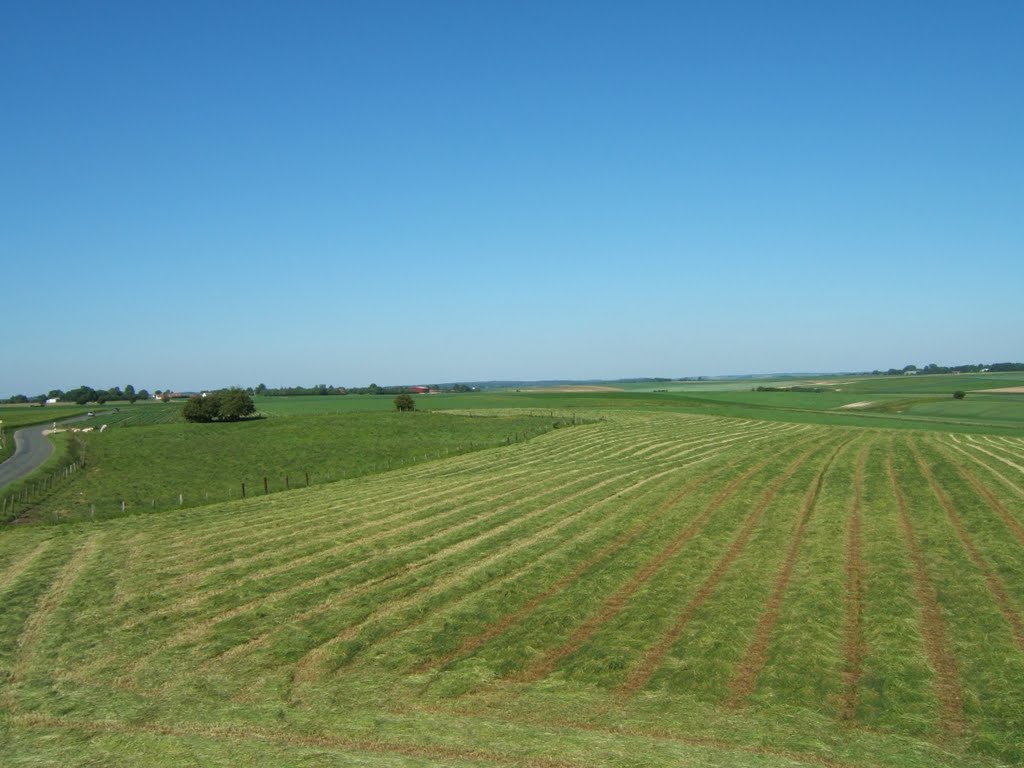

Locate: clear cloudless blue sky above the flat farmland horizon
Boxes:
[0,0,1024,396]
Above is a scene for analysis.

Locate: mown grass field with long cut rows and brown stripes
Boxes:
[0,410,1024,768]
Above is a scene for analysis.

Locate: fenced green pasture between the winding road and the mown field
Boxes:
[12,415,569,520]
